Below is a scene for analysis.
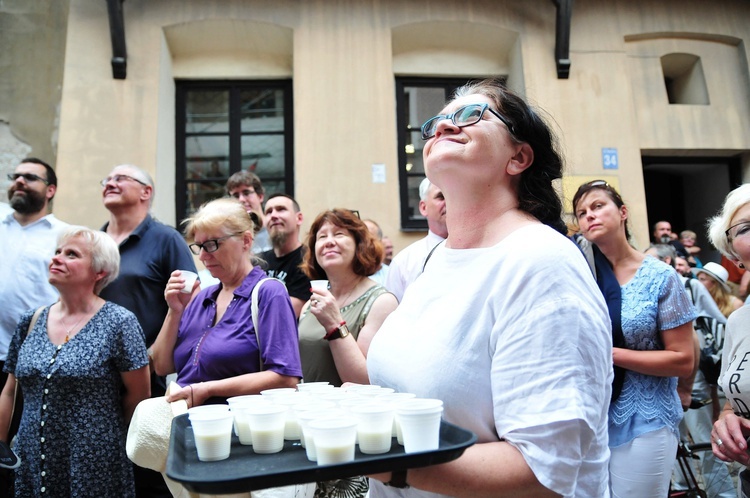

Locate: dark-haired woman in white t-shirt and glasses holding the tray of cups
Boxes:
[367,81,612,498]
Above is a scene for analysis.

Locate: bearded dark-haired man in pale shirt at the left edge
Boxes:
[0,157,68,496]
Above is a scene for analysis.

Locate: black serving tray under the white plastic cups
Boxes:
[167,414,477,494]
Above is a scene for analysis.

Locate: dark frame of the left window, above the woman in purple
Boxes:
[175,79,294,226]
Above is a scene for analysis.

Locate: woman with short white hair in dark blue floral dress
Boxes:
[0,226,150,498]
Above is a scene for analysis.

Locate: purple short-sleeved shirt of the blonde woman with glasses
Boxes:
[174,266,302,402]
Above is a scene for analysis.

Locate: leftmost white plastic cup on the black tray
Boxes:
[188,405,234,462]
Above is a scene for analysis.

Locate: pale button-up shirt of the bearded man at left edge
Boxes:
[0,209,68,361]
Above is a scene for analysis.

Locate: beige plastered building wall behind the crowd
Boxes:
[10,0,750,249]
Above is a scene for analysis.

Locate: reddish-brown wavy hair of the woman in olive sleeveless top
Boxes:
[300,208,383,280]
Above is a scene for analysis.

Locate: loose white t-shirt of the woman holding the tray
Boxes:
[367,225,613,498]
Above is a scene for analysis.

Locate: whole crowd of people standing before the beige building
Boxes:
[0,80,750,498]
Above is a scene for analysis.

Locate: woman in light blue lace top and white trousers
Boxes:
[573,180,695,498]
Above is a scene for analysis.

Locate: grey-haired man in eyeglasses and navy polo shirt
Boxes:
[100,164,196,498]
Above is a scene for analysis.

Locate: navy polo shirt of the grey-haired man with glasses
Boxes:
[100,215,196,346]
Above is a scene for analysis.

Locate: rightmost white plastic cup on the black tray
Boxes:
[396,399,443,453]
